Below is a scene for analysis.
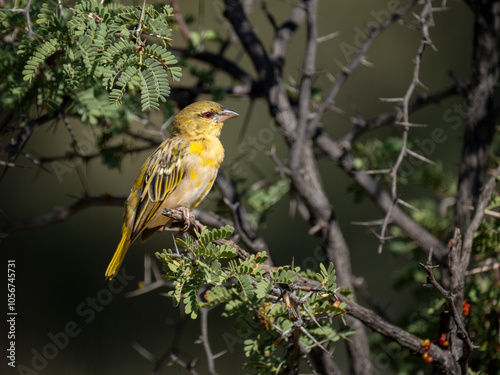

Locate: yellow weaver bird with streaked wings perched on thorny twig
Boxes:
[106,101,239,279]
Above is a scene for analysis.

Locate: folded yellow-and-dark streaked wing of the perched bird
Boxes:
[131,138,189,241]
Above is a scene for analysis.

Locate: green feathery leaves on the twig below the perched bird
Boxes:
[157,226,353,374]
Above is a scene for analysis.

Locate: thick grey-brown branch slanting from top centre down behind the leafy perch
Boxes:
[225,0,372,374]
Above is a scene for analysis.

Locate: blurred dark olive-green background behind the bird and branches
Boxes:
[0,1,473,375]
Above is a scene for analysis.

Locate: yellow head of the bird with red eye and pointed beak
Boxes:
[173,101,239,138]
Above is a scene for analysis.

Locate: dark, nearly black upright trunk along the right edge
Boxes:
[453,0,500,233]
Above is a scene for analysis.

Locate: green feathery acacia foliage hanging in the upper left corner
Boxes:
[0,0,181,114]
